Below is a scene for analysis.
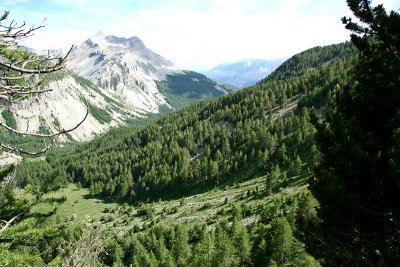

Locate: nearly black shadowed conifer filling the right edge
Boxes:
[313,0,400,266]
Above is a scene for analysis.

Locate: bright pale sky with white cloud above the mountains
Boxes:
[0,0,400,71]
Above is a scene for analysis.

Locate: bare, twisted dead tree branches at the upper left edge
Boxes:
[0,11,89,156]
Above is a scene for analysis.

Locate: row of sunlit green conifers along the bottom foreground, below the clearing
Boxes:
[102,191,320,267]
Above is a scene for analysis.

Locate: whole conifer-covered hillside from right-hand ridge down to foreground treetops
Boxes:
[0,43,356,266]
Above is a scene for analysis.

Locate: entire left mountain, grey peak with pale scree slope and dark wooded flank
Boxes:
[0,32,229,141]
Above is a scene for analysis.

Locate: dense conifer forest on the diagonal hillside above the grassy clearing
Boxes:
[19,43,355,203]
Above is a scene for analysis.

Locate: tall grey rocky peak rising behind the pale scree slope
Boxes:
[68,32,231,113]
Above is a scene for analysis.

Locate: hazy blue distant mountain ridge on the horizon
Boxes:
[203,59,286,88]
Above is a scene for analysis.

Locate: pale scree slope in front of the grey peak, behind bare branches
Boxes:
[0,72,128,141]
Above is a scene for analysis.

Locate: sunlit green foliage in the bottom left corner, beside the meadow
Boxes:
[0,166,65,266]
